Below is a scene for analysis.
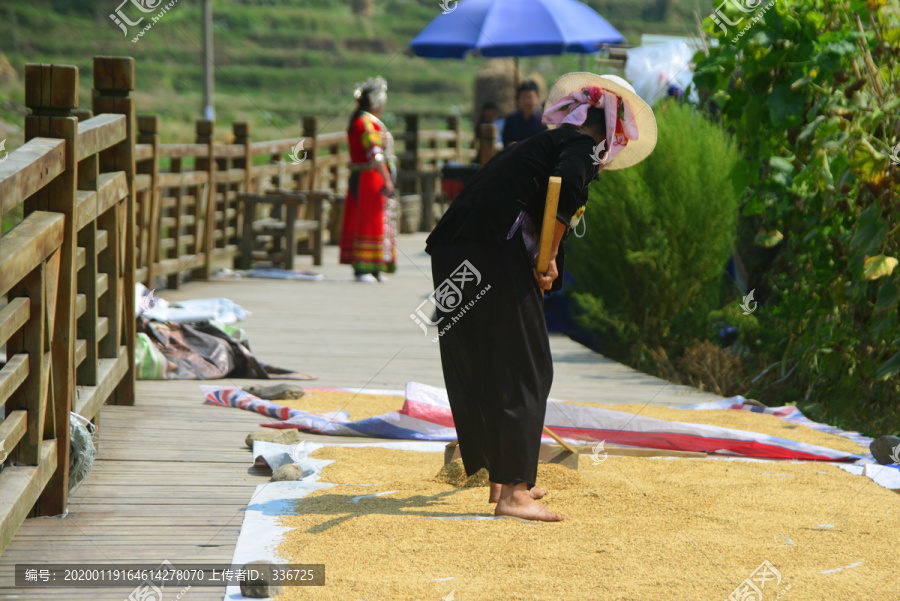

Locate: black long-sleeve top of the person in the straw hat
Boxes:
[425,127,598,290]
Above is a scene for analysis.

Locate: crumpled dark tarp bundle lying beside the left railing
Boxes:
[137,317,315,380]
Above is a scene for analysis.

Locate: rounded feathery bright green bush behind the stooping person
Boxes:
[567,103,740,366]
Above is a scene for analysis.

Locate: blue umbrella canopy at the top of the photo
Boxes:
[409,0,625,59]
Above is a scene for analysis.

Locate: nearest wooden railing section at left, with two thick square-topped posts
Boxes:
[0,57,135,550]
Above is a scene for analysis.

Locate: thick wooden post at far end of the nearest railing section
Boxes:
[94,56,137,405]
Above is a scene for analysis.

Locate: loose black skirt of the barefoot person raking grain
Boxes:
[431,233,553,488]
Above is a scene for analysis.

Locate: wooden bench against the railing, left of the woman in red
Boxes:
[238,190,333,269]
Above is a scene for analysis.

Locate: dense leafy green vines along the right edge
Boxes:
[694,0,900,434]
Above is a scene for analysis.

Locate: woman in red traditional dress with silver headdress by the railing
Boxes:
[341,77,396,283]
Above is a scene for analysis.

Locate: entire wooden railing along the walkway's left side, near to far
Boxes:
[0,57,492,553]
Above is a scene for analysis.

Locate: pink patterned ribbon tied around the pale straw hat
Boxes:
[541,86,638,166]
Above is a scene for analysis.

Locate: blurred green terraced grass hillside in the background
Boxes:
[0,0,712,148]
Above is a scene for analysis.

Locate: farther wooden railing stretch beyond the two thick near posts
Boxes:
[122,109,478,288]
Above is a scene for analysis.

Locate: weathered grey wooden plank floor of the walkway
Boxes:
[0,234,719,601]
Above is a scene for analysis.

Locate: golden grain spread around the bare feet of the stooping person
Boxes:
[276,447,900,601]
